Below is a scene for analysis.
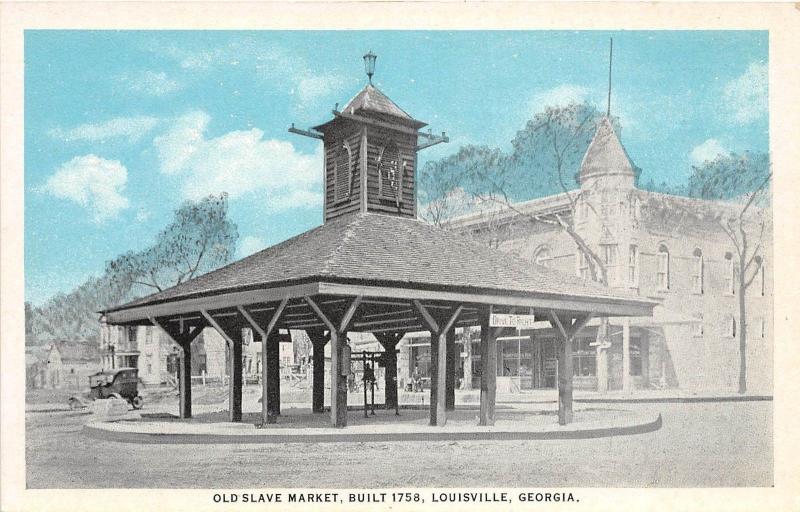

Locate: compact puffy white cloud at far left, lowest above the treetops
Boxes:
[39,155,128,223]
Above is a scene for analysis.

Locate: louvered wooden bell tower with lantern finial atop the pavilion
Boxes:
[289,52,449,222]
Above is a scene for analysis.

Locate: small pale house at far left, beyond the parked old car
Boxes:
[25,341,101,389]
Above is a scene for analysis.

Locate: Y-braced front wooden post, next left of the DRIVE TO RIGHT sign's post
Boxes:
[414,300,464,427]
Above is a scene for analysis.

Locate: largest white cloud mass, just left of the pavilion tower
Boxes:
[154,112,322,209]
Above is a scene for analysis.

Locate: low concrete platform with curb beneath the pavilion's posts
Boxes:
[84,408,662,444]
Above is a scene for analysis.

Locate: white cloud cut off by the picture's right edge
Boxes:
[722,62,769,124]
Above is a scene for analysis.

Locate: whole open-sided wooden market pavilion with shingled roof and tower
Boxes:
[98,54,657,427]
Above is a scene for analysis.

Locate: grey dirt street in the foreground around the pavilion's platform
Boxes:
[26,402,773,488]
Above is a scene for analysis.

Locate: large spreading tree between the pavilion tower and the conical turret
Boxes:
[420,103,620,386]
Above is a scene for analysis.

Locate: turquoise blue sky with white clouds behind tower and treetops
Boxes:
[25,31,769,304]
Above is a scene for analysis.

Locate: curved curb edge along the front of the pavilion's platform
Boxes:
[83,413,663,444]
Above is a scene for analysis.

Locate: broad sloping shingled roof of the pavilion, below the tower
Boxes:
[107,213,644,312]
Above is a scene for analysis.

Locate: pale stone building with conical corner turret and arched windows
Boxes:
[434,119,773,393]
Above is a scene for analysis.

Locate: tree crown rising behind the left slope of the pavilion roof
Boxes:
[106,193,239,292]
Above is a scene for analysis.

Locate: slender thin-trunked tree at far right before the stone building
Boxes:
[687,152,772,394]
